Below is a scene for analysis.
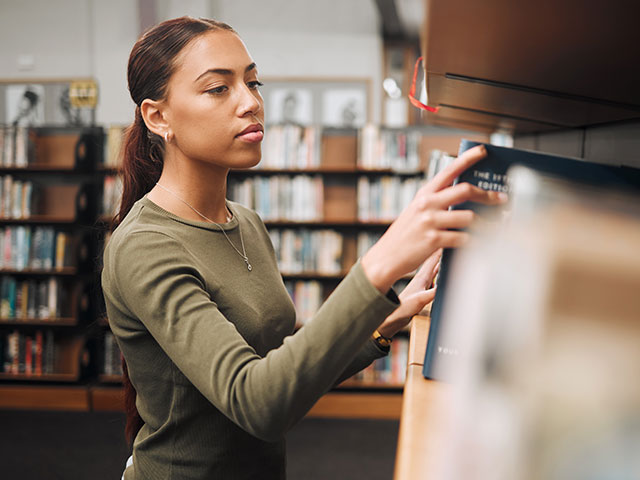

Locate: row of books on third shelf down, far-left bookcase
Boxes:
[0,225,73,270]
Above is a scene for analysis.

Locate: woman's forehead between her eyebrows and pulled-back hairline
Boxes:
[173,30,253,81]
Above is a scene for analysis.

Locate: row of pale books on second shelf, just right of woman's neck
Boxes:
[229,175,324,221]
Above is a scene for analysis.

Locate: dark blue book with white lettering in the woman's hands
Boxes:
[423,140,640,381]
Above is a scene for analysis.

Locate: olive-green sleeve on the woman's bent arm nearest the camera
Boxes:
[105,232,398,441]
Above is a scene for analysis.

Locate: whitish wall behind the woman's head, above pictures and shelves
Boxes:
[0,0,382,124]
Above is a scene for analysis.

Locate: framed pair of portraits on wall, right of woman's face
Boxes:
[260,78,371,128]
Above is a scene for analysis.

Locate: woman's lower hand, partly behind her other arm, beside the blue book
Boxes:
[378,249,442,338]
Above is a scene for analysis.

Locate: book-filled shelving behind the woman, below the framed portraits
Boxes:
[79,122,480,418]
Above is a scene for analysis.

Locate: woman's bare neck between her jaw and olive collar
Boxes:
[147,154,229,223]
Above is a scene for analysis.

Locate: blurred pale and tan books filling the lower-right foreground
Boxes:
[425,169,640,480]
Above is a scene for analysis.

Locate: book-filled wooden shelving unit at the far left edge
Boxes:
[0,126,103,398]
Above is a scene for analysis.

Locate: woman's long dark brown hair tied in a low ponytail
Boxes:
[112,17,235,443]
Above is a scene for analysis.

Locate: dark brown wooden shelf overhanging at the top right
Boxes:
[422,0,640,133]
